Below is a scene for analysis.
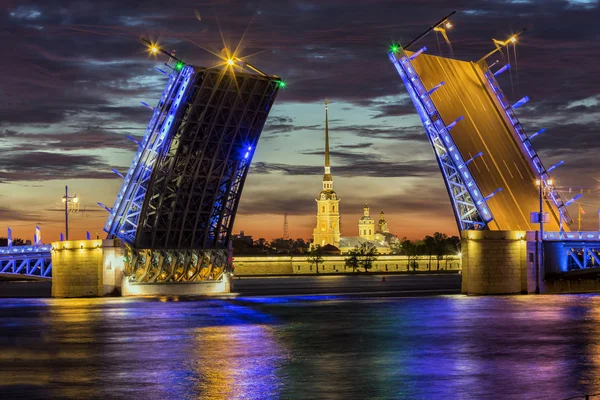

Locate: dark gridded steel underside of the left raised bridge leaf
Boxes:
[133,70,278,249]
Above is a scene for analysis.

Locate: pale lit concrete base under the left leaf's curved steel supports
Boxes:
[121,274,231,296]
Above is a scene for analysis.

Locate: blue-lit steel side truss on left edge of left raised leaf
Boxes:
[104,66,194,244]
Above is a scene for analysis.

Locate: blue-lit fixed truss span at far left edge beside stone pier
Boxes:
[0,244,52,280]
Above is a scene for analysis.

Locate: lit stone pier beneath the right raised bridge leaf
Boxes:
[461,230,545,295]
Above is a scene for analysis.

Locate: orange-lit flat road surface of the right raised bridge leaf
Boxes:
[407,52,559,230]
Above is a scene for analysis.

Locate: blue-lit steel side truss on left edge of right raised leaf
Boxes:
[388,49,493,231]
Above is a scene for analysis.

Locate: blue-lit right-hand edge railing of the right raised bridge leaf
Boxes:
[477,60,572,223]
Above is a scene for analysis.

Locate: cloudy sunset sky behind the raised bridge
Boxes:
[0,0,600,242]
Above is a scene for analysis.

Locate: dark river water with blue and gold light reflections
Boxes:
[0,295,600,399]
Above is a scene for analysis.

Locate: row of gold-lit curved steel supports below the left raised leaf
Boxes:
[124,248,228,283]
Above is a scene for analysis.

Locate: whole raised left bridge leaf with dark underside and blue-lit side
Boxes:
[105,67,280,256]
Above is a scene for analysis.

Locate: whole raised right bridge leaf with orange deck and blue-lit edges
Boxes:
[389,49,571,231]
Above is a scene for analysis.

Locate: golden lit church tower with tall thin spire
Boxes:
[313,99,340,247]
